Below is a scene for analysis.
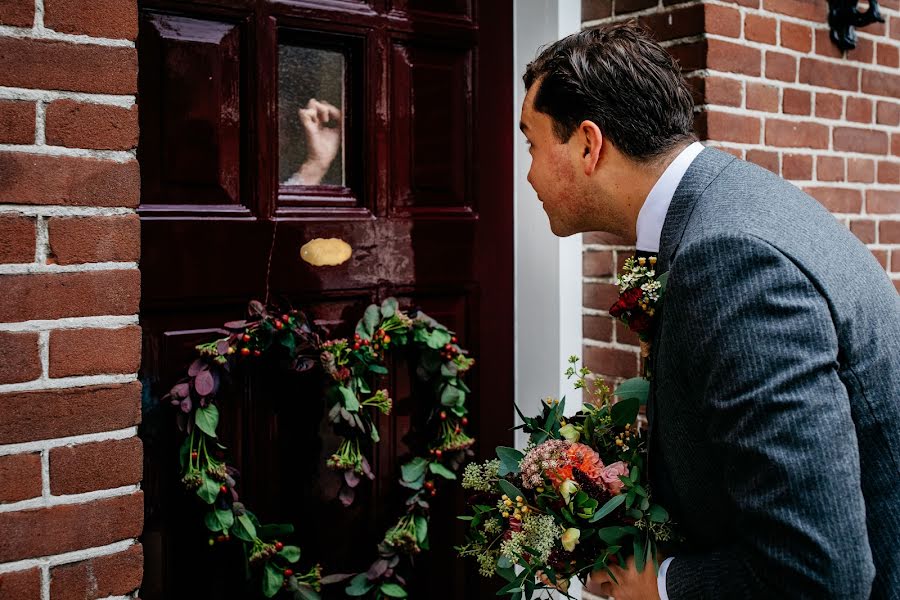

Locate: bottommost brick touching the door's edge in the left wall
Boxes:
[50,544,144,600]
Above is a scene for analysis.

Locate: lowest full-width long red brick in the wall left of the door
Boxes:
[0,492,144,562]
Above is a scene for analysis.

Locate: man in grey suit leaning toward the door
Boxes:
[521,25,900,600]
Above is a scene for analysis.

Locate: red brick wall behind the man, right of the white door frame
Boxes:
[582,0,900,384]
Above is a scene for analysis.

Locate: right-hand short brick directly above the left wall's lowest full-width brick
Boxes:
[50,437,143,495]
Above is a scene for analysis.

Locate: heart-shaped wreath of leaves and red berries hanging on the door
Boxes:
[163,298,475,600]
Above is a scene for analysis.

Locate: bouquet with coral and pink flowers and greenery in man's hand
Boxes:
[457,356,674,600]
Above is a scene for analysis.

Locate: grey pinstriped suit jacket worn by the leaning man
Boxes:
[648,149,900,600]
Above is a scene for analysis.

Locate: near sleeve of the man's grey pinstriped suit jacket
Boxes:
[660,235,874,600]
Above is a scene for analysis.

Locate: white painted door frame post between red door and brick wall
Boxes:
[511,0,582,598]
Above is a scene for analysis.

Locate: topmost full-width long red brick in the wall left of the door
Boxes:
[0,37,137,94]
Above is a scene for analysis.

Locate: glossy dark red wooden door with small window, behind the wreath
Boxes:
[138,0,513,600]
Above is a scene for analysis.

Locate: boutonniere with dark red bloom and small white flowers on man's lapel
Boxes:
[609,256,669,377]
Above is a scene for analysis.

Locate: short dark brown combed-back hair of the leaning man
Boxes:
[524,23,696,161]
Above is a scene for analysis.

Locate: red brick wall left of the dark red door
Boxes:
[0,0,143,600]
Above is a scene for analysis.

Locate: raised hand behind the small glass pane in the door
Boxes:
[284,98,342,185]
